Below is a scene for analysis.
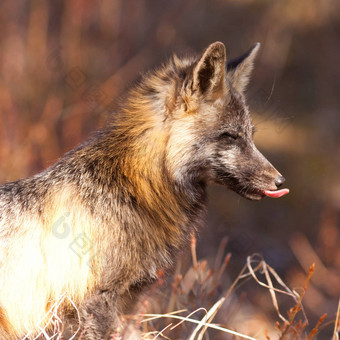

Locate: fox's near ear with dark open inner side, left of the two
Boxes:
[193,41,226,94]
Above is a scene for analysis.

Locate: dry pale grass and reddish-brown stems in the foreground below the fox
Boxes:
[23,238,340,340]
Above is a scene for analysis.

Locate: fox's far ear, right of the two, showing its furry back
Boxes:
[227,43,260,93]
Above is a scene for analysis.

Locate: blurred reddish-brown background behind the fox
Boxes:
[0,0,340,339]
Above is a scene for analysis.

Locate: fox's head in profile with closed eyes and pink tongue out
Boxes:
[123,42,288,200]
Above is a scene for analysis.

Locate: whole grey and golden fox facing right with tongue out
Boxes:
[0,42,289,340]
